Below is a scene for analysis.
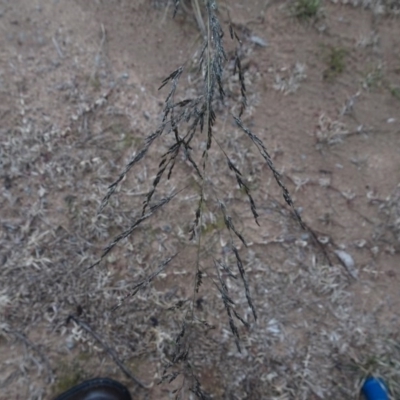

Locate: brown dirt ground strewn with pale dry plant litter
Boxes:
[0,0,400,400]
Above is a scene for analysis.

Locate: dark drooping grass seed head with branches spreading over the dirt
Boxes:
[91,0,304,398]
